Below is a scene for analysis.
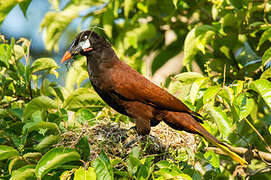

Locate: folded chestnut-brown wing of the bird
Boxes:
[110,61,200,116]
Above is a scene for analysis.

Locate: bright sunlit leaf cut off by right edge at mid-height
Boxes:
[249,79,271,108]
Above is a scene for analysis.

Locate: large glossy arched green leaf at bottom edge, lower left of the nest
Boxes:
[35,147,80,178]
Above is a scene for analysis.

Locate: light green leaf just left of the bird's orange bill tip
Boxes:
[31,58,59,73]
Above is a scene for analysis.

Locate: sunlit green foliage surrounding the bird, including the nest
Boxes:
[0,0,271,179]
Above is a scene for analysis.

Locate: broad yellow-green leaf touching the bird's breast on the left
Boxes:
[63,88,101,110]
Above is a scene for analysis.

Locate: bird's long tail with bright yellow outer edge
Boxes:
[194,123,248,166]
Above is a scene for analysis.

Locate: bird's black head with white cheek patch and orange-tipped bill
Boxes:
[61,30,107,63]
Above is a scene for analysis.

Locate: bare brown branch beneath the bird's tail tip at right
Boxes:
[205,147,271,163]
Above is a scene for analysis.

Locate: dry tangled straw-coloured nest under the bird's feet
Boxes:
[56,117,200,160]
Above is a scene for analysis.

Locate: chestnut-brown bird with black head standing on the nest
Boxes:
[61,30,248,166]
